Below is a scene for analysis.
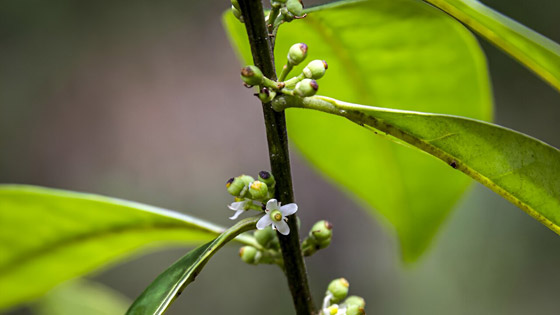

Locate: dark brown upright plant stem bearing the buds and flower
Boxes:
[239,0,315,315]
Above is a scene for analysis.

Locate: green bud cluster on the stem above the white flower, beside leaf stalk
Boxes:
[241,43,328,102]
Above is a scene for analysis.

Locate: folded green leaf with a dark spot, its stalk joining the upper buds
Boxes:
[275,96,560,234]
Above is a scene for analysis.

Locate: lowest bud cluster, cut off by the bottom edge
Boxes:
[319,278,366,315]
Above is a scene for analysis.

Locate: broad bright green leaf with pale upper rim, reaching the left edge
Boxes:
[0,185,252,308]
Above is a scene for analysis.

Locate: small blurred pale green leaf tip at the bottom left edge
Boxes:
[33,279,131,315]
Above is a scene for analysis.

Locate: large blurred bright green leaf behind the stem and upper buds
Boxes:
[225,0,492,261]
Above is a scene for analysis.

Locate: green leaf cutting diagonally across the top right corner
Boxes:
[424,0,560,91]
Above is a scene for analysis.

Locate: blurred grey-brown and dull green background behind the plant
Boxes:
[0,0,560,315]
